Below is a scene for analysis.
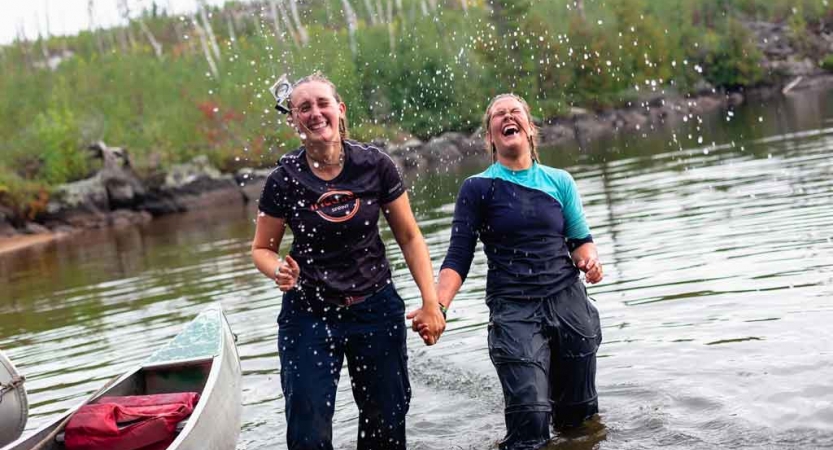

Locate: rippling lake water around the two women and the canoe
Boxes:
[0,92,833,450]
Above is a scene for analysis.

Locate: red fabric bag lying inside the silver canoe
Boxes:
[64,392,200,450]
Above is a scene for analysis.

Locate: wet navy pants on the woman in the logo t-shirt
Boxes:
[278,285,411,450]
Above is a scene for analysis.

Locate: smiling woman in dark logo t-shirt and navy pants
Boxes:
[252,74,445,450]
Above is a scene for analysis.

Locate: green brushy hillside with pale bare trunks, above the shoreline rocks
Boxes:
[0,0,833,219]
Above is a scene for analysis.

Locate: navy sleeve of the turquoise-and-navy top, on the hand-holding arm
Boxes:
[440,178,483,281]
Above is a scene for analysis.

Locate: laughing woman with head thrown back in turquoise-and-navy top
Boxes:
[426,94,602,450]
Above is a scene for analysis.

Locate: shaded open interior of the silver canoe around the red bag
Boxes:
[12,358,214,450]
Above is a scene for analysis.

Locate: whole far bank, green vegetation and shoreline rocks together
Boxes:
[0,0,833,253]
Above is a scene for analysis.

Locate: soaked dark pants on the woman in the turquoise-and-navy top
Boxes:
[489,281,602,450]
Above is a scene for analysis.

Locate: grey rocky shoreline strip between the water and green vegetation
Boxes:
[0,17,833,252]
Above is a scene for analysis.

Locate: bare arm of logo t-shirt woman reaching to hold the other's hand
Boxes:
[383,192,445,345]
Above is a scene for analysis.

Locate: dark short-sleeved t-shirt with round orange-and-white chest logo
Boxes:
[258,140,405,301]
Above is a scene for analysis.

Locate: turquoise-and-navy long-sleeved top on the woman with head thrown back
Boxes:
[442,162,593,300]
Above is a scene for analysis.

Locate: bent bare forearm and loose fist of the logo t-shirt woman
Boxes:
[252,213,300,291]
